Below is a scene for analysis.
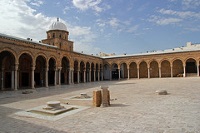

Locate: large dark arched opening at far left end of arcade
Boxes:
[0,51,17,90]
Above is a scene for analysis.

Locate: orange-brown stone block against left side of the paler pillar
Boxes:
[93,90,102,107]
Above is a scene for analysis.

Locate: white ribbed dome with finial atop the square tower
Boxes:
[49,18,67,31]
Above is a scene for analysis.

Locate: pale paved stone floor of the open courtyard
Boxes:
[0,78,200,133]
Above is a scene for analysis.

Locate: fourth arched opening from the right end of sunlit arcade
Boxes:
[150,61,159,78]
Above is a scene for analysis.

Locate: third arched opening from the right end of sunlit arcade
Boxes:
[161,60,171,77]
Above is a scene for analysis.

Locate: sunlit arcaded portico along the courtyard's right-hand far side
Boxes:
[104,51,200,79]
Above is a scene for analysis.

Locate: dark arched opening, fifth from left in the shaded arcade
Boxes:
[61,57,69,84]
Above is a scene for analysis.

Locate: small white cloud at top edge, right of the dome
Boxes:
[72,0,103,12]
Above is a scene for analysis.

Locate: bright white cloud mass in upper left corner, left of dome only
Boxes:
[0,0,49,40]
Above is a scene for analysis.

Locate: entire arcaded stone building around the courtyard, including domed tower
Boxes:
[0,20,200,90]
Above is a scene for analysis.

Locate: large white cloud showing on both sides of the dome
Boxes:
[0,0,100,53]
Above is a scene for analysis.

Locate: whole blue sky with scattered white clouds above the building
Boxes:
[0,0,200,54]
